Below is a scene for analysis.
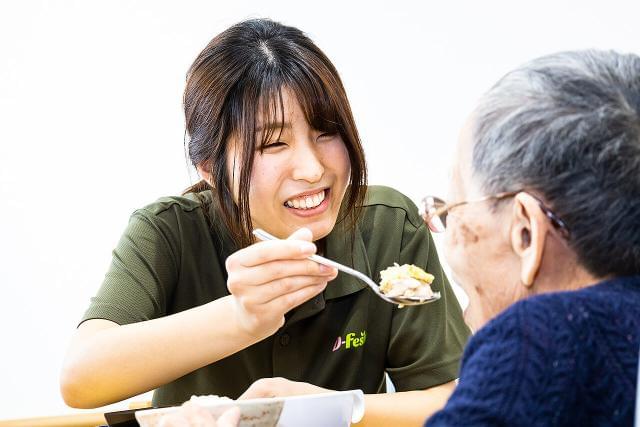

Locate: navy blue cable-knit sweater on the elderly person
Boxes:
[426,276,640,427]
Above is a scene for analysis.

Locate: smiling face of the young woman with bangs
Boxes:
[227,90,351,240]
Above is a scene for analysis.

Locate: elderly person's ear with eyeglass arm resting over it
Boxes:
[511,192,547,287]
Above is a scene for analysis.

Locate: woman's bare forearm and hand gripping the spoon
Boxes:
[60,229,337,408]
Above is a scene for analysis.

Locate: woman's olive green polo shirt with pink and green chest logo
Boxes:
[83,187,469,406]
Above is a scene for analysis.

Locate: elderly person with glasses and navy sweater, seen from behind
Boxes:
[425,51,640,427]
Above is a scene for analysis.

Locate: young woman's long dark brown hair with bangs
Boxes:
[184,19,367,247]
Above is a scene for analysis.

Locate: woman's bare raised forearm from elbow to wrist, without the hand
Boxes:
[60,296,252,408]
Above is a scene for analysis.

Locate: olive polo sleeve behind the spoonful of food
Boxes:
[387,220,470,391]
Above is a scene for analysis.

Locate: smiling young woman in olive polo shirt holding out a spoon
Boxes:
[61,20,469,425]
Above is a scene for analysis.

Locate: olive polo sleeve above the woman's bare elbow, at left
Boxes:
[82,209,178,325]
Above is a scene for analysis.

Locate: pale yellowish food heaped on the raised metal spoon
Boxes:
[380,263,434,300]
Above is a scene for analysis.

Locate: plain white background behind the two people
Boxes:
[0,0,640,419]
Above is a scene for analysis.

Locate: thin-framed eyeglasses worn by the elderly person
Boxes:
[422,190,570,240]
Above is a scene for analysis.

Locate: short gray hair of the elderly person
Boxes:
[472,50,640,277]
